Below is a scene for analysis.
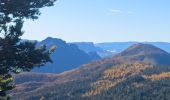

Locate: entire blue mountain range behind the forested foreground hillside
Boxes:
[33,37,170,73]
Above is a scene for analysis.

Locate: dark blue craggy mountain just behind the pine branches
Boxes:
[33,37,100,73]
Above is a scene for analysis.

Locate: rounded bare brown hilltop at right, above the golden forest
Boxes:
[113,43,170,66]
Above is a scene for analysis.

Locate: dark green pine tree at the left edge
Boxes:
[0,0,56,99]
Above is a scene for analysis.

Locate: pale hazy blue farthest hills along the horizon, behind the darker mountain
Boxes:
[71,42,170,58]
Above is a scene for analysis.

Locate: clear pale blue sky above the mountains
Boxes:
[22,0,170,43]
